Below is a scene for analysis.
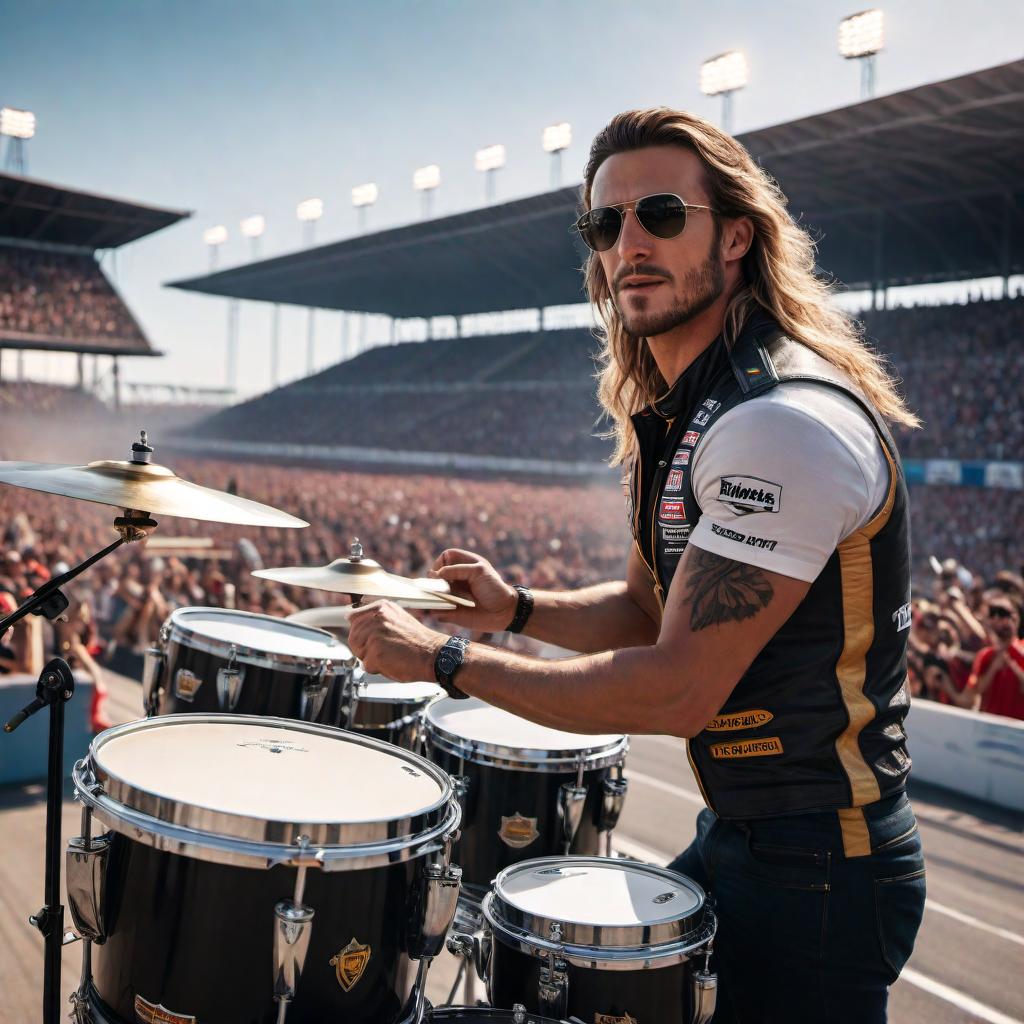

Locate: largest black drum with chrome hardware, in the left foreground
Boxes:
[68,715,460,1024]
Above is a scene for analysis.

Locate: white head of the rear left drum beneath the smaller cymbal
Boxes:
[171,608,352,662]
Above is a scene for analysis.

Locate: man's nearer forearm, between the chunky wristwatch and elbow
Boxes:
[456,643,694,735]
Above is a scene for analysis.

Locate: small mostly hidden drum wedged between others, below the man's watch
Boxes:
[337,668,444,751]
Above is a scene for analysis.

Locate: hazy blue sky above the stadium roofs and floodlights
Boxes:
[0,0,1024,393]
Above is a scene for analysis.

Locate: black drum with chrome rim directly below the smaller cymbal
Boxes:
[142,608,355,725]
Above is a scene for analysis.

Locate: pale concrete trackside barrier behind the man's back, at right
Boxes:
[906,700,1024,811]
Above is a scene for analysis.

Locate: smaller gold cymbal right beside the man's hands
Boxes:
[258,540,475,608]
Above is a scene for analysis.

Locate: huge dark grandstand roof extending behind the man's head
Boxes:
[172,60,1024,316]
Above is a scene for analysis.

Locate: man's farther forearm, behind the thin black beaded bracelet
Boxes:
[523,581,658,653]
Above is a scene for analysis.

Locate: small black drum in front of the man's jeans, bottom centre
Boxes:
[483,857,717,1024]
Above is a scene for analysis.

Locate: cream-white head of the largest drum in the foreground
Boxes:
[94,716,443,824]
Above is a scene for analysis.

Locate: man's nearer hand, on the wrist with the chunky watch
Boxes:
[348,601,446,683]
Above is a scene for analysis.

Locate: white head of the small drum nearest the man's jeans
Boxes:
[498,857,703,927]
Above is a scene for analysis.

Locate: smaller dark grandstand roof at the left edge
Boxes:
[0,174,191,249]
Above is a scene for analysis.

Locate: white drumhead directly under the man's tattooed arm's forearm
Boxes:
[427,697,624,752]
